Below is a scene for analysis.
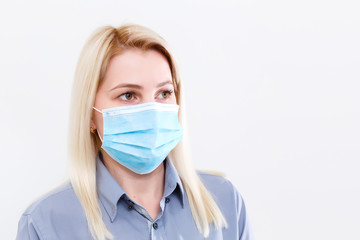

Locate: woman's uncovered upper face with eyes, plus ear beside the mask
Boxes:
[91,49,176,136]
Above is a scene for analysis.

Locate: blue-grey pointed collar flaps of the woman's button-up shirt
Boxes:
[96,152,185,222]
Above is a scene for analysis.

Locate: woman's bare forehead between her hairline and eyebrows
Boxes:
[103,48,171,85]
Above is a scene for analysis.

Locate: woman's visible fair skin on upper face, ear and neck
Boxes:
[91,49,176,219]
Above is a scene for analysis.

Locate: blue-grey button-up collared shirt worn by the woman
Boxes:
[16,155,253,240]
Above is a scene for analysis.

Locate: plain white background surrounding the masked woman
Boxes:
[0,0,360,240]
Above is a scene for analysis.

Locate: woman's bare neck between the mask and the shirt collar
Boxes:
[101,150,165,208]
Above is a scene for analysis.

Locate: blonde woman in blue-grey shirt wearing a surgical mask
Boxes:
[17,25,253,240]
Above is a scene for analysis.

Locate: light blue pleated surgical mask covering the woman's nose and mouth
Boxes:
[93,102,183,174]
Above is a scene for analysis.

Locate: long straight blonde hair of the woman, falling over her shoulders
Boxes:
[69,25,227,240]
